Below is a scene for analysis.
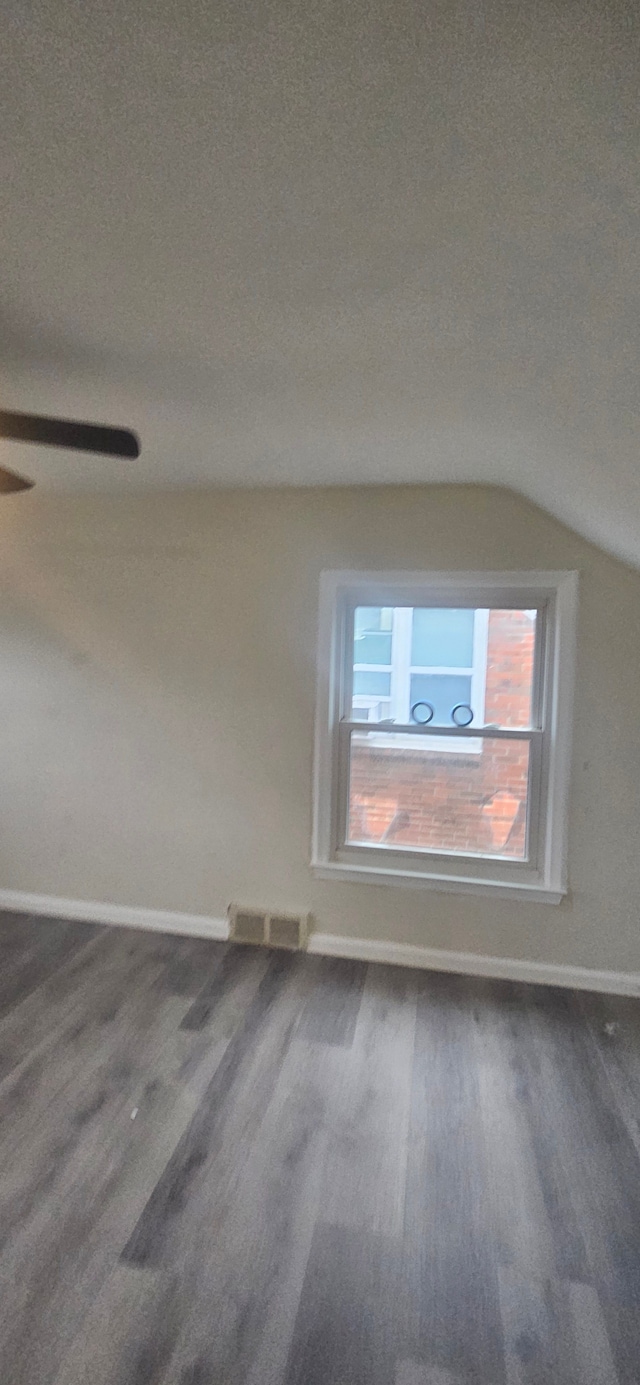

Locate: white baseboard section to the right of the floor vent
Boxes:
[303,933,640,996]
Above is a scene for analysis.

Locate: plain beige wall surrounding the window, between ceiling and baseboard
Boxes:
[0,486,640,971]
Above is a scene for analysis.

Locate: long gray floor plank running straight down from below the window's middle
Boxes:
[405,975,504,1385]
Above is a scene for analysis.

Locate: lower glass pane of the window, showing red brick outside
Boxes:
[348,731,529,860]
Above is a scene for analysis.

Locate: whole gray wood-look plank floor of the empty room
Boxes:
[0,914,640,1385]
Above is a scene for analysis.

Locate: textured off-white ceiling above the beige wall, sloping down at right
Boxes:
[0,0,640,562]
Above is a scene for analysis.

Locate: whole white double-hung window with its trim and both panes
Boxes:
[313,572,576,903]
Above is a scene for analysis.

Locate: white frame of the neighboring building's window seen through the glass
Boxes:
[352,607,489,755]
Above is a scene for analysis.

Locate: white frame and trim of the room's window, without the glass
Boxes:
[312,572,578,903]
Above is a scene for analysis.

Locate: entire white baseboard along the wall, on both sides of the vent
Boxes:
[0,889,640,996]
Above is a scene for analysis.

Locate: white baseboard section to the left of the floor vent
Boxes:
[0,889,229,939]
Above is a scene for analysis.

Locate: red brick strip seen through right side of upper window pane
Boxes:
[485,609,537,727]
